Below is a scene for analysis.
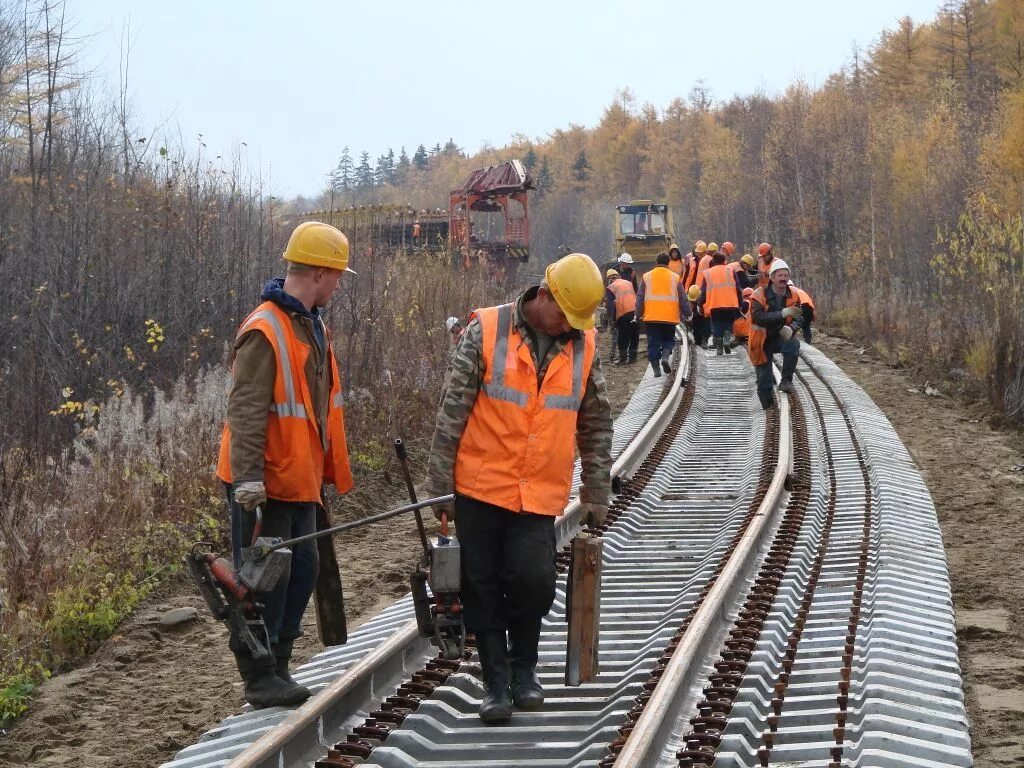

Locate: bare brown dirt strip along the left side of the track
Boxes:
[0,358,644,768]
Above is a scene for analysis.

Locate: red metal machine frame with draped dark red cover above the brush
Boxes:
[449,160,534,264]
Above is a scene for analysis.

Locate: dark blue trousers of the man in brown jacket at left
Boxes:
[228,490,317,650]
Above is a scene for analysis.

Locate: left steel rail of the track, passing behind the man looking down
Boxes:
[214,333,689,768]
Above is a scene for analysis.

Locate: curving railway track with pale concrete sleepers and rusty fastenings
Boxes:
[166,337,971,768]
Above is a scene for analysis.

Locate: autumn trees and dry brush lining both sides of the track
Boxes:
[0,0,1024,721]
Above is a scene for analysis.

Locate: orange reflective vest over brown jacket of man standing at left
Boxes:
[217,301,352,502]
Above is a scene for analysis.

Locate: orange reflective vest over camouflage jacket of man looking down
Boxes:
[455,304,597,515]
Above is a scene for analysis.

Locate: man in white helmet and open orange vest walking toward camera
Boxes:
[748,259,803,411]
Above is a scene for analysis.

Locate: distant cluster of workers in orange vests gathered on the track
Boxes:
[605,240,814,409]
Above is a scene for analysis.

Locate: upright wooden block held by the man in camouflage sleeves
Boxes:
[565,535,603,686]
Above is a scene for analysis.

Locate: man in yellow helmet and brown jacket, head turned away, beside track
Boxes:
[217,221,352,709]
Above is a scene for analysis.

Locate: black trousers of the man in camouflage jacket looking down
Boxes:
[455,494,555,654]
